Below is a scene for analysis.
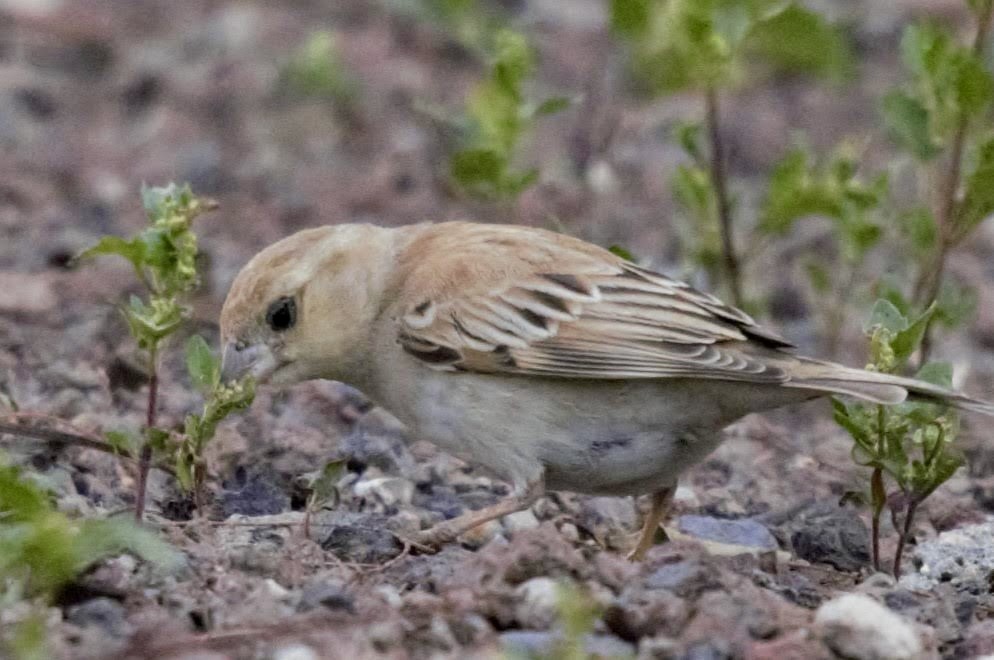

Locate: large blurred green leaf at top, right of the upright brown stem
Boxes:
[748,4,854,80]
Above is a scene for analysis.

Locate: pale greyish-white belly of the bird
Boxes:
[369,350,812,495]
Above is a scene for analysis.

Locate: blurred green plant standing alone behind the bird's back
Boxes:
[449,29,569,199]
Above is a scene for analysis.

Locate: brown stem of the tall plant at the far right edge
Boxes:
[914,3,994,365]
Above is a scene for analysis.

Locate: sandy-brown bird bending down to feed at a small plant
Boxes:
[220,221,994,560]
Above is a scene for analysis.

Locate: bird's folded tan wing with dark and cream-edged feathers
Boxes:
[398,223,790,383]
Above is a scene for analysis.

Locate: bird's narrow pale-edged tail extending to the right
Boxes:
[784,360,994,417]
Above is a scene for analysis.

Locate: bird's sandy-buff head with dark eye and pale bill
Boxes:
[221,225,392,385]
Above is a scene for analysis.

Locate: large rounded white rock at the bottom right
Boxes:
[815,594,923,660]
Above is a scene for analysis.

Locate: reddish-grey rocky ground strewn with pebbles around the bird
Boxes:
[0,0,994,660]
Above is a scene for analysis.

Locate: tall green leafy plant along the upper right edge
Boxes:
[881,0,994,361]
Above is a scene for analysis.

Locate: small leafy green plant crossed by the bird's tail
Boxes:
[833,300,963,577]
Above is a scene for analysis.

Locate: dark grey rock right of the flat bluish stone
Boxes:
[790,506,870,571]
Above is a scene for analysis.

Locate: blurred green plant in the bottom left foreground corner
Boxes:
[0,455,179,660]
